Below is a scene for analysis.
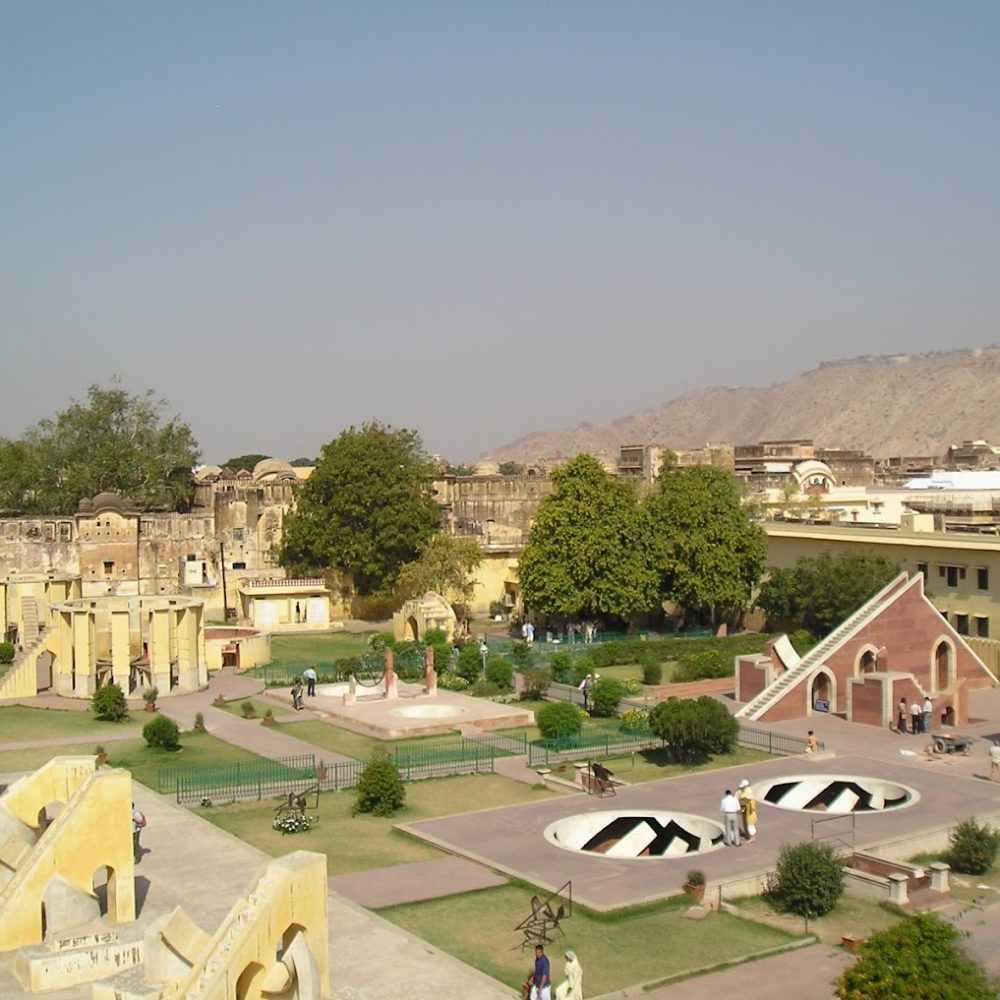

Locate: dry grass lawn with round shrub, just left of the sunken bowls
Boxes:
[197,774,552,875]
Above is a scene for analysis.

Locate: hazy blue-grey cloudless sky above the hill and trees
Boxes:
[0,0,1000,461]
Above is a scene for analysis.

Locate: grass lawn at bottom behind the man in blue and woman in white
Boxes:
[379,884,796,996]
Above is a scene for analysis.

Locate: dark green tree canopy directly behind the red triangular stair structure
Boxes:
[755,552,899,636]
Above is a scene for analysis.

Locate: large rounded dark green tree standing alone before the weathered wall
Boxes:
[280,422,441,595]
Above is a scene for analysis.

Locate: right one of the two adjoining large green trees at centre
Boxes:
[646,465,767,623]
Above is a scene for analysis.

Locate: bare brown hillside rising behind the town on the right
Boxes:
[490,347,1000,462]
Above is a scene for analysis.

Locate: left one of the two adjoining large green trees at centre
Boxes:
[518,455,658,619]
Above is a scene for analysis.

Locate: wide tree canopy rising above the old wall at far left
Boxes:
[0,379,199,514]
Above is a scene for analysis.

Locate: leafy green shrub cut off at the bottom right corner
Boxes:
[836,913,996,1000]
